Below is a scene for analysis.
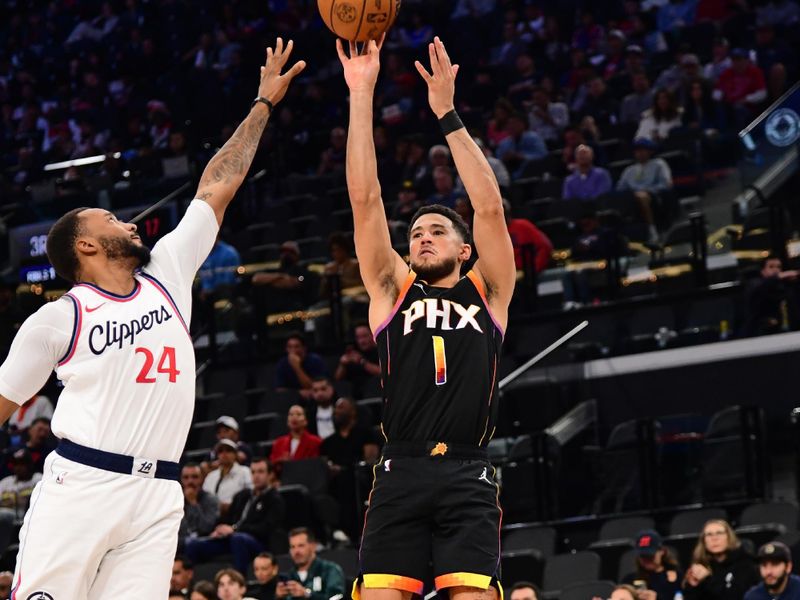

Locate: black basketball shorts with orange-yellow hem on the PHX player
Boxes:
[354,442,502,598]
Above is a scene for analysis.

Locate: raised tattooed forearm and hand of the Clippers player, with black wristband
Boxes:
[195,38,306,223]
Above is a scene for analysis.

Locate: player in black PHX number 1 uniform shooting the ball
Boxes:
[337,37,515,600]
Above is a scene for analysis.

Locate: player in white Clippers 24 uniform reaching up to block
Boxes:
[0,39,305,600]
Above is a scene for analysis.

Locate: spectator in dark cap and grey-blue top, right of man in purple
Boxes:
[617,138,672,241]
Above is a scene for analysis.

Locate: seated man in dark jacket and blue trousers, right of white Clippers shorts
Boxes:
[186,458,286,573]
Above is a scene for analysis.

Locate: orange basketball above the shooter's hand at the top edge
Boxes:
[317,0,400,42]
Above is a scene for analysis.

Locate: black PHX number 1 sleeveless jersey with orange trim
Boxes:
[375,271,503,447]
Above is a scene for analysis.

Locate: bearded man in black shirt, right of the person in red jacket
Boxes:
[320,398,380,540]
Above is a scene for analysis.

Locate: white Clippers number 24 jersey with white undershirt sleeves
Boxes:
[0,200,218,462]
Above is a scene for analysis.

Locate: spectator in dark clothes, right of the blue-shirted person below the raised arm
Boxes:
[252,240,311,313]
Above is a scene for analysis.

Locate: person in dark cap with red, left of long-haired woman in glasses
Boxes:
[622,529,683,600]
